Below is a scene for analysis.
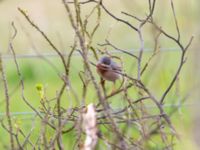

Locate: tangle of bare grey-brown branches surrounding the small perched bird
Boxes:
[0,0,193,150]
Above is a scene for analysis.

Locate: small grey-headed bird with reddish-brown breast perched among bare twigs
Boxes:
[96,56,121,83]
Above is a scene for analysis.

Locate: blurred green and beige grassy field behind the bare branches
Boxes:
[0,0,200,150]
